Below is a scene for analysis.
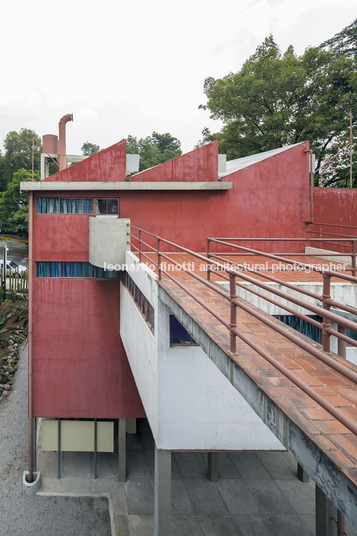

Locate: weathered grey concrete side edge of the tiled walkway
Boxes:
[159,286,357,527]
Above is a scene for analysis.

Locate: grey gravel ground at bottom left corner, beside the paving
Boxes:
[0,346,111,536]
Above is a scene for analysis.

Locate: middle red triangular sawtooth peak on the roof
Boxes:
[131,141,218,182]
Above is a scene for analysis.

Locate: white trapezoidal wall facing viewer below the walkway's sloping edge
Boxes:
[157,302,284,450]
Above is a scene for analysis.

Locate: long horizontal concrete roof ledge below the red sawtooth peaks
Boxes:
[20,179,233,192]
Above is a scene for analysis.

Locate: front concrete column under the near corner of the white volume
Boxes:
[154,445,171,536]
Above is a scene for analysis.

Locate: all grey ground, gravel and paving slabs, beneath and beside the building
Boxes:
[0,344,356,536]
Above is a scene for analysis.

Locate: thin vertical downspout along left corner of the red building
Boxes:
[28,191,34,482]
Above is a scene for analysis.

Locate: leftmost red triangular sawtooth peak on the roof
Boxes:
[44,140,126,182]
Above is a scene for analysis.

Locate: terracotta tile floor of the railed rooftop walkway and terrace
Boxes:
[141,254,357,490]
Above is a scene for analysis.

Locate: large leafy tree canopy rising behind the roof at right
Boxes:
[200,25,357,185]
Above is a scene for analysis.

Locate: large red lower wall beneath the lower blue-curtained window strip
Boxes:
[33,279,145,418]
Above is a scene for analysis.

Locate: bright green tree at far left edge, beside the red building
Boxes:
[0,169,40,236]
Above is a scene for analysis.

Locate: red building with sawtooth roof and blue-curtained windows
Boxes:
[21,141,357,536]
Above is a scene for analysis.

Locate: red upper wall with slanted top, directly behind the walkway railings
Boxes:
[120,143,310,251]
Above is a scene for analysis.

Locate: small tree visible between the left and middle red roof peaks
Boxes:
[126,132,182,171]
